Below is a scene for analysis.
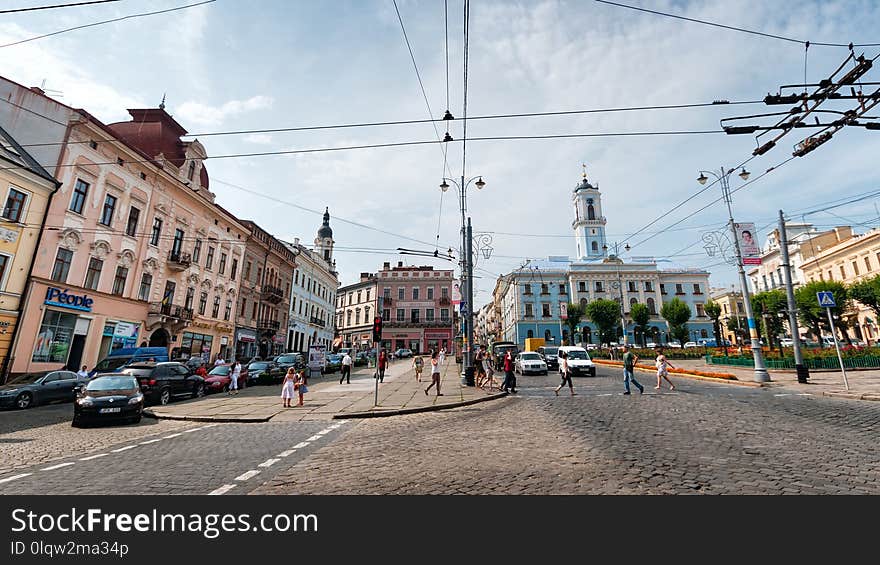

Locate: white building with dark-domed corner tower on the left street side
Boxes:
[287,209,339,353]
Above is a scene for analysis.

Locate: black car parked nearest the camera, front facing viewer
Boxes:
[71,374,144,427]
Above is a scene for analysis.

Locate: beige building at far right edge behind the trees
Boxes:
[801,228,880,343]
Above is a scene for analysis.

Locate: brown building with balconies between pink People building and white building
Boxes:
[235,220,299,360]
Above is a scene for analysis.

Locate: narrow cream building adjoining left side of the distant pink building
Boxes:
[334,273,381,350]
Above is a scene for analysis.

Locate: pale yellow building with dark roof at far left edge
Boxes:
[0,128,60,376]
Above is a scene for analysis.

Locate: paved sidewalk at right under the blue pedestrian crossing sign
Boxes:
[670,359,880,400]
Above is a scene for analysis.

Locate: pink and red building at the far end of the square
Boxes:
[376,262,454,353]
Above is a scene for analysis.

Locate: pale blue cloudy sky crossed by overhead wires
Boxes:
[0,0,880,306]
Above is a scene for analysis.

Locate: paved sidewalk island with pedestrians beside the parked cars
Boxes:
[144,359,506,423]
